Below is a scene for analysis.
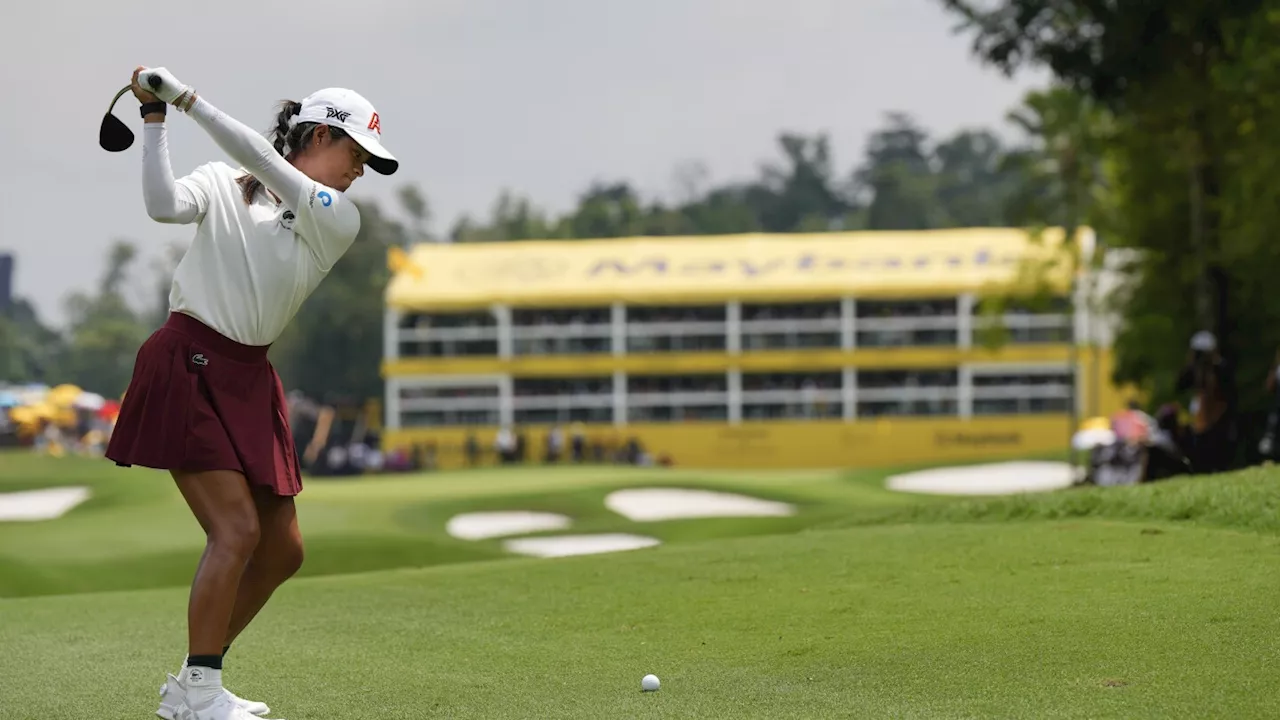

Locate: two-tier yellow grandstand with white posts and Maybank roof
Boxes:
[383,228,1123,468]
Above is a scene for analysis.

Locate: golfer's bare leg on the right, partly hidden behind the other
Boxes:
[223,488,302,644]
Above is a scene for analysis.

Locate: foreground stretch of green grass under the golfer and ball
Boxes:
[0,512,1280,720]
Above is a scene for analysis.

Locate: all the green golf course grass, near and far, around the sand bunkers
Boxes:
[0,455,1280,720]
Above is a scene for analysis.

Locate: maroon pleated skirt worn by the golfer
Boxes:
[106,313,302,496]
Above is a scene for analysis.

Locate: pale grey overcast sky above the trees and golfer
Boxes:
[0,0,1047,323]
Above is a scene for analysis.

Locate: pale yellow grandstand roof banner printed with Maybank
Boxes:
[387,228,1083,310]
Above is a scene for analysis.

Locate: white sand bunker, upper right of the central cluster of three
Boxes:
[604,488,795,523]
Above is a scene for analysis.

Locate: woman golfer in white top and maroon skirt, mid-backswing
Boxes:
[106,68,398,720]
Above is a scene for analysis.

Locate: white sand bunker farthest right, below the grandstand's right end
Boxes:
[886,462,1075,495]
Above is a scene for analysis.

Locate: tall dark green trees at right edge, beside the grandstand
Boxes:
[938,0,1280,409]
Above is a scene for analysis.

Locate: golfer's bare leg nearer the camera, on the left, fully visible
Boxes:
[170,470,259,655]
